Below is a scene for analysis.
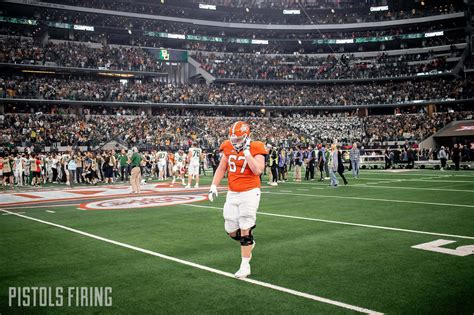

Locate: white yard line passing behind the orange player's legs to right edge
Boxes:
[182,203,474,240]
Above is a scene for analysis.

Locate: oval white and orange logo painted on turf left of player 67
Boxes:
[79,195,206,210]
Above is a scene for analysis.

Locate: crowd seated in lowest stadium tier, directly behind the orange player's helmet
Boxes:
[0,110,473,151]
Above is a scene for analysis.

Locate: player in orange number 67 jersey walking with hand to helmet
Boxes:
[209,121,268,278]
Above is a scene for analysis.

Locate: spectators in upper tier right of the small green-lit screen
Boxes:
[193,53,449,80]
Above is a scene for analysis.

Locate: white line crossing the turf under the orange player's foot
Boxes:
[0,209,383,315]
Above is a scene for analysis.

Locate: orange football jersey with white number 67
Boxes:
[220,140,268,192]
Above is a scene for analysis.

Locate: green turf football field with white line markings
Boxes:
[0,170,474,314]
